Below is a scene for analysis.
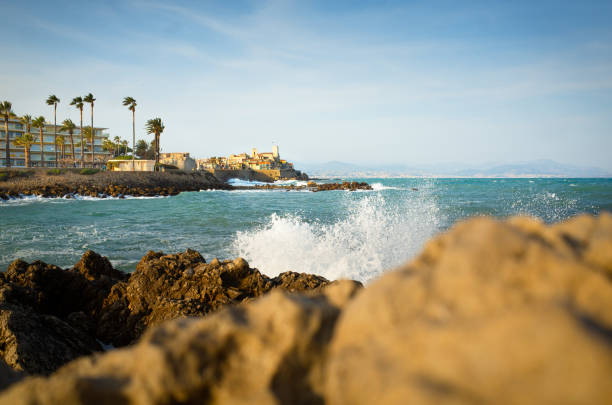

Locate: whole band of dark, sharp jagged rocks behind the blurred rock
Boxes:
[0,250,328,374]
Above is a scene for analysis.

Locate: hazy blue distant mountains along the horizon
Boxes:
[295,159,612,177]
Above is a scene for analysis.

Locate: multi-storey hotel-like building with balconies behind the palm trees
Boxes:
[0,118,111,167]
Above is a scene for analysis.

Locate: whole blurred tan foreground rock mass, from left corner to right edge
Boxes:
[0,215,612,404]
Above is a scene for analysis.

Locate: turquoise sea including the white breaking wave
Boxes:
[0,178,612,283]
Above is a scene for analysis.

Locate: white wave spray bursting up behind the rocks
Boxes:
[232,192,441,282]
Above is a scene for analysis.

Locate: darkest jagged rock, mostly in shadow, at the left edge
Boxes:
[0,252,125,374]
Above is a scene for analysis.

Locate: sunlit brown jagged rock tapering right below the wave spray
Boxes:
[97,249,328,346]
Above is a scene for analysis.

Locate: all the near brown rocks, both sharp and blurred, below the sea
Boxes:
[0,213,612,404]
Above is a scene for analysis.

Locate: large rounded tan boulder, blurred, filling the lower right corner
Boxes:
[325,214,612,404]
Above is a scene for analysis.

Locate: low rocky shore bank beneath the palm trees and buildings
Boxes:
[0,169,232,200]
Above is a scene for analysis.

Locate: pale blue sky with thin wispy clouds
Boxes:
[0,0,612,169]
